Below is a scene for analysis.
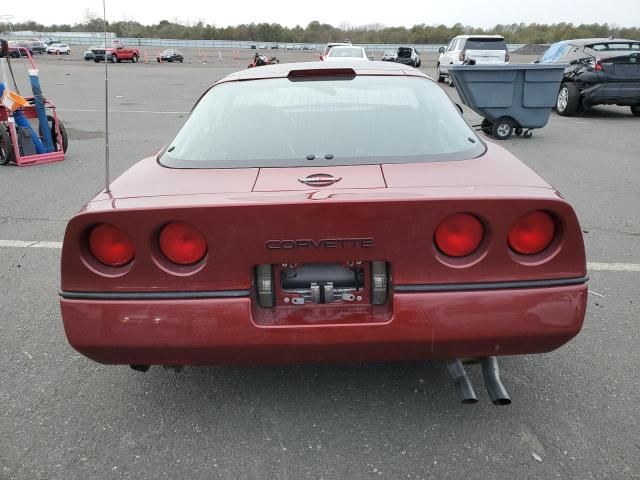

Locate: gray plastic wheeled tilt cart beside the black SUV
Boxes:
[449,63,566,140]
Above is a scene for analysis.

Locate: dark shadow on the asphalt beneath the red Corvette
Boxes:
[130,357,537,415]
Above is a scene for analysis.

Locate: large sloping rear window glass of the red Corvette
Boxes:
[160,76,485,168]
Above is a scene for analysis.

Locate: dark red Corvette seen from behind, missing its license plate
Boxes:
[60,61,587,402]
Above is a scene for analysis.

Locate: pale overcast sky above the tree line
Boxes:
[0,0,640,27]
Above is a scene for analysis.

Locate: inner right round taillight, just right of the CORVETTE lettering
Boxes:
[435,213,484,257]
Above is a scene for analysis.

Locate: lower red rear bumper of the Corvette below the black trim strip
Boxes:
[61,283,587,365]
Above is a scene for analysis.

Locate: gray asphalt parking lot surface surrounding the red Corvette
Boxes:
[0,47,640,480]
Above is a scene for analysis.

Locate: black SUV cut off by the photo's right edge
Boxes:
[536,38,640,116]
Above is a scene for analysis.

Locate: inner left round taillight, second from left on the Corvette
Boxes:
[160,222,207,265]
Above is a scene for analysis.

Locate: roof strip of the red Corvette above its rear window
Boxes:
[216,58,430,83]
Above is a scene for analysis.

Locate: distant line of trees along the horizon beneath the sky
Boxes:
[0,17,640,44]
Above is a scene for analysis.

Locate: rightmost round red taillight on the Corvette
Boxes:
[509,210,556,255]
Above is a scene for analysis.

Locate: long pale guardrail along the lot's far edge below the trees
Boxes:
[7,35,523,53]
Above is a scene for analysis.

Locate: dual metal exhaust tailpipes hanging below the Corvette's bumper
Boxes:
[447,357,511,405]
